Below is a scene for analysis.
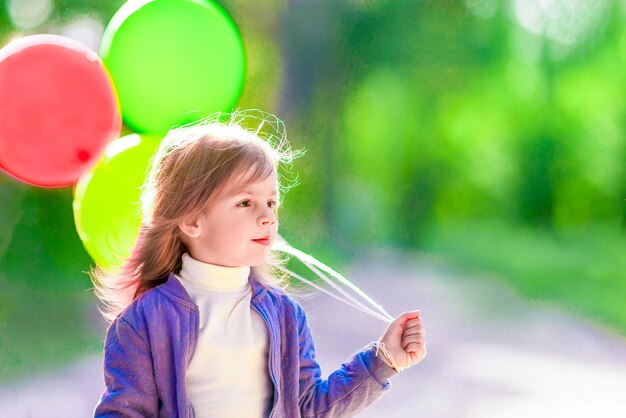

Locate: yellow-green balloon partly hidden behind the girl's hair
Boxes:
[73,134,160,267]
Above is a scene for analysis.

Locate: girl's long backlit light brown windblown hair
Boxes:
[90,111,303,323]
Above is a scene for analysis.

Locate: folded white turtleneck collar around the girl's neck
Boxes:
[178,253,250,292]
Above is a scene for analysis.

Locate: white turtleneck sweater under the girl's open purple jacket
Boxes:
[176,253,273,418]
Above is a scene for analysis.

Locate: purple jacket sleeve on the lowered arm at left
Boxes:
[94,316,158,418]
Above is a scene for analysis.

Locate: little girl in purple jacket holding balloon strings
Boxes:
[93,115,426,418]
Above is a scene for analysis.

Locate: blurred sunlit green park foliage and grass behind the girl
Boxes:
[0,0,626,416]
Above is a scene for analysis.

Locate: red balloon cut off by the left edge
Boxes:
[0,35,121,187]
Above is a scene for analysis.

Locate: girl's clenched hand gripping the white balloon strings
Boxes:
[380,311,426,370]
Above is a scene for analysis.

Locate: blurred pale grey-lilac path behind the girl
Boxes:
[0,253,626,418]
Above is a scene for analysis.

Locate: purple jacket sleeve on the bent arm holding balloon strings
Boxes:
[299,308,397,418]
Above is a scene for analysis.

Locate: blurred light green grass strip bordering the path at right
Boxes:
[423,221,626,335]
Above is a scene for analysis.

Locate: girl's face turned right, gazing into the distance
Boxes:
[181,168,278,267]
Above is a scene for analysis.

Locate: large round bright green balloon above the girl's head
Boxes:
[100,0,246,135]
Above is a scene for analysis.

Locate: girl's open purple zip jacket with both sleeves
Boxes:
[94,274,396,418]
